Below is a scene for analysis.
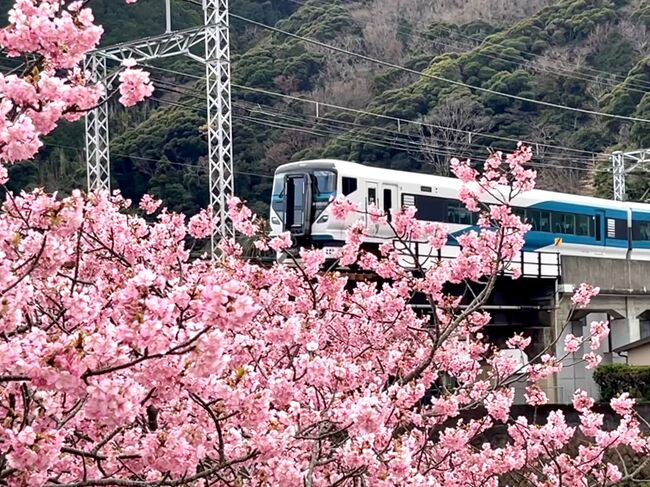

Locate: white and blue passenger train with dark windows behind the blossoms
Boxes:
[269,159,650,260]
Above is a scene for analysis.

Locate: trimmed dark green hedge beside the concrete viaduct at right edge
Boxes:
[594,364,650,402]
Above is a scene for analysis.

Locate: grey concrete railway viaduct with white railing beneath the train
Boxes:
[392,248,650,403]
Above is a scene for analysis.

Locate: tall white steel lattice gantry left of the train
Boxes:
[85,0,234,256]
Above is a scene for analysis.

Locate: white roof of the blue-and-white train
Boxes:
[276,159,650,211]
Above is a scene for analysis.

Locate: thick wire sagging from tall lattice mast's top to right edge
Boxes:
[230,13,650,123]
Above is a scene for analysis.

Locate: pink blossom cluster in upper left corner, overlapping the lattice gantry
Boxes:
[0,0,153,179]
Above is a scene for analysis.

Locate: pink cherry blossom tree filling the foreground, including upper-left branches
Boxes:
[0,0,650,487]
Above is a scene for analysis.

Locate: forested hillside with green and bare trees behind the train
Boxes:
[0,0,650,212]
